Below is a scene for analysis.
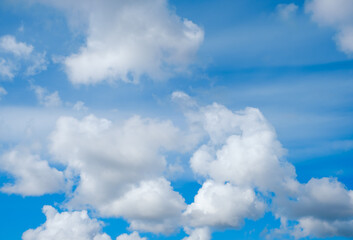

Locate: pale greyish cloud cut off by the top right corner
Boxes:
[305,0,353,55]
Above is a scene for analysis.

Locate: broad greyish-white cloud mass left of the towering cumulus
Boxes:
[51,115,185,233]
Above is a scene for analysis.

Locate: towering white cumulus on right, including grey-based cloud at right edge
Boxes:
[173,93,353,239]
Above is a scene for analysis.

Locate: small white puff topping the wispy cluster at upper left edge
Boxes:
[0,35,33,57]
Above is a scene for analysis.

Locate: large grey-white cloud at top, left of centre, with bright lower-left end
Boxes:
[34,0,203,84]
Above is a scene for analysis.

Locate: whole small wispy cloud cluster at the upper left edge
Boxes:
[0,35,47,79]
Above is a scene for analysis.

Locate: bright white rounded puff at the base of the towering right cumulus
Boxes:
[184,180,265,229]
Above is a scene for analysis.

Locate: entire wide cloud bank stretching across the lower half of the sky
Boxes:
[0,92,353,240]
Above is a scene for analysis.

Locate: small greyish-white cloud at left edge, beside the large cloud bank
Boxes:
[0,149,65,196]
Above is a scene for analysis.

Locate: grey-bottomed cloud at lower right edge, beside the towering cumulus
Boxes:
[275,178,353,238]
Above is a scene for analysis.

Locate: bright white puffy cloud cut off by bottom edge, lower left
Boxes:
[22,206,111,240]
